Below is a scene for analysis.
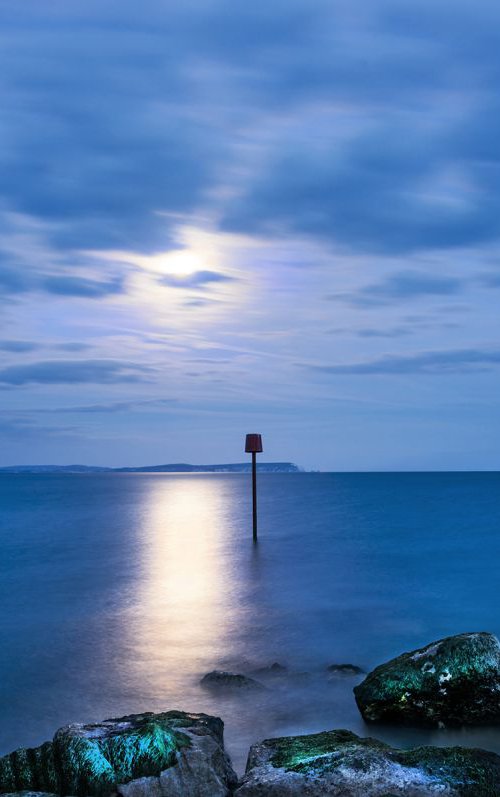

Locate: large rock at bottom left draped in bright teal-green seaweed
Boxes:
[0,711,236,797]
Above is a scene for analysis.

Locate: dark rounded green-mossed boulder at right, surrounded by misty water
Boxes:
[354,633,500,727]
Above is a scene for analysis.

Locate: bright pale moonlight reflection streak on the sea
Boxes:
[122,476,236,696]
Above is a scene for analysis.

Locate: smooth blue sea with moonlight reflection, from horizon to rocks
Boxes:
[0,473,500,771]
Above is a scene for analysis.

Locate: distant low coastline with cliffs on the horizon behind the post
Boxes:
[0,462,303,474]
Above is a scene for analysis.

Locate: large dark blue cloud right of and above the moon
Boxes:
[223,118,500,254]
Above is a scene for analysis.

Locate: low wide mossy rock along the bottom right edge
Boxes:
[234,730,500,797]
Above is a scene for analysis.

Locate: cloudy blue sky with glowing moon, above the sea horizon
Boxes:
[0,0,500,471]
